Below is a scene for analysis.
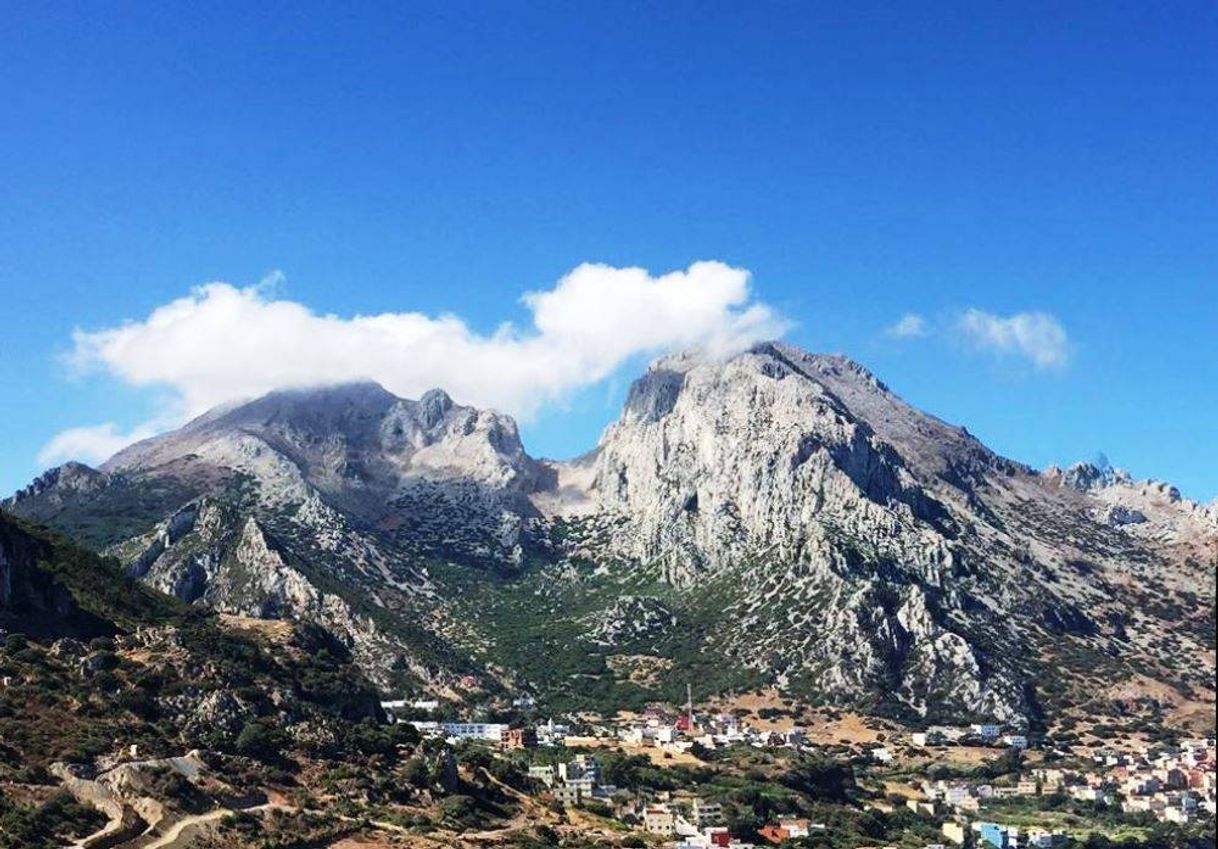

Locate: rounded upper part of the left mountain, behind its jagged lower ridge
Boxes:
[104,384,544,560]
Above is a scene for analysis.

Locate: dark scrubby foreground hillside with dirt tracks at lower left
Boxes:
[0,513,582,849]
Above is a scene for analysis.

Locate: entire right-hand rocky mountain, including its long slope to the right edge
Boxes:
[546,343,1218,721]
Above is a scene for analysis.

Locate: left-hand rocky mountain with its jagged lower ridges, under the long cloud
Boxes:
[10,384,546,689]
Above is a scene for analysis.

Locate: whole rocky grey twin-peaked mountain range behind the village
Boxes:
[0,342,1218,727]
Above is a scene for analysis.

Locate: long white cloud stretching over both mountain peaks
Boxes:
[40,262,788,459]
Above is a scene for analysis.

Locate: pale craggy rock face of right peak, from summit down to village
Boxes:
[540,345,1027,719]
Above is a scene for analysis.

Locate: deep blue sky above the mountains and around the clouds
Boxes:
[0,2,1218,501]
